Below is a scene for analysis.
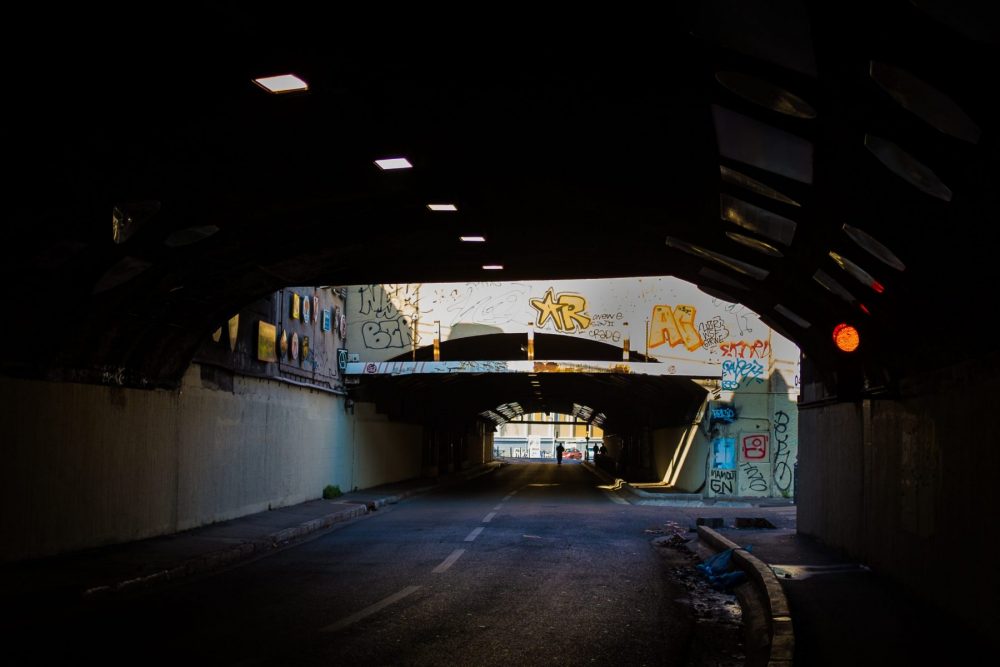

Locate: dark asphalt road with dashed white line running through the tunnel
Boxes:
[8,462,744,666]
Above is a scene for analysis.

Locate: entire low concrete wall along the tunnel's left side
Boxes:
[0,365,422,561]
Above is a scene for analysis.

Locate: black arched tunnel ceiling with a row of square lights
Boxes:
[0,0,1000,386]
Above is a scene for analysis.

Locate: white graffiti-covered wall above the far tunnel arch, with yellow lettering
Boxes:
[345,276,799,378]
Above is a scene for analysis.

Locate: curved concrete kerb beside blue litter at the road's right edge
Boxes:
[698,526,795,667]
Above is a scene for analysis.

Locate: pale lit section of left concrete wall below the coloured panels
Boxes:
[177,369,351,530]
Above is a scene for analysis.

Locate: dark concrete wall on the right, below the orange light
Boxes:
[798,355,1000,633]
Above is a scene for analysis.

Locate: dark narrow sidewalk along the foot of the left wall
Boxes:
[0,462,503,608]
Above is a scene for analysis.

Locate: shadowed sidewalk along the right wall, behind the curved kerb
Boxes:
[584,462,996,667]
